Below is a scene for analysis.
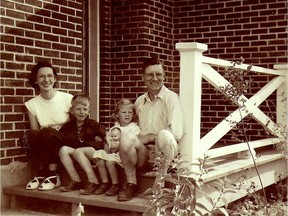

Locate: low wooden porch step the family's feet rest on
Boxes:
[3,173,155,215]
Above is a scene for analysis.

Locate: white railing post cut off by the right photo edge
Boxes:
[274,64,288,141]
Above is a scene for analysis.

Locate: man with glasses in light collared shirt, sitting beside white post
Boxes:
[117,58,184,201]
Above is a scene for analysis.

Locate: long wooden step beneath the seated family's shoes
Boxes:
[3,170,155,216]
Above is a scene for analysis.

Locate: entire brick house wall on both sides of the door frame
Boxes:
[0,0,287,164]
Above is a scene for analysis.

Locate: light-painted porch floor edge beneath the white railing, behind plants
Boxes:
[196,149,287,215]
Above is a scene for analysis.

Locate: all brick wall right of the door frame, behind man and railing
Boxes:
[101,0,287,143]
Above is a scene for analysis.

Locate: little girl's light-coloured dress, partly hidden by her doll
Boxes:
[93,122,141,167]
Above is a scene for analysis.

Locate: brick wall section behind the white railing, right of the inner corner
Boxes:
[173,0,288,145]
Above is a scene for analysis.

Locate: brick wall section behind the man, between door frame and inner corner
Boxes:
[100,0,179,123]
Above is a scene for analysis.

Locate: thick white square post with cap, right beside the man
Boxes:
[176,43,208,166]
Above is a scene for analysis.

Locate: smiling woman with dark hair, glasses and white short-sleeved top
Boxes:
[25,62,73,190]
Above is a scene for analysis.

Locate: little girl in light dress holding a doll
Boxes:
[93,99,140,196]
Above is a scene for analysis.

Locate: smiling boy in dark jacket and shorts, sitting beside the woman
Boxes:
[59,95,106,194]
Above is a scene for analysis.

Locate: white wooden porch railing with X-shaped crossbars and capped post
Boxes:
[176,43,288,162]
